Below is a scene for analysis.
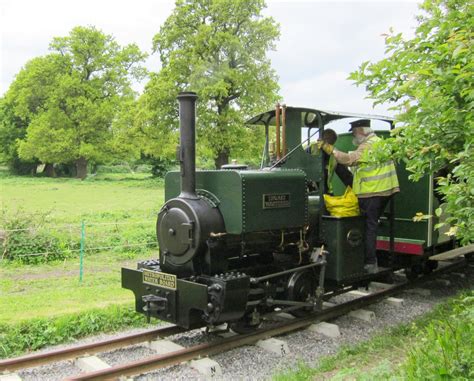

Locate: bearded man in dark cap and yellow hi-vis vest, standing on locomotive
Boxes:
[318,119,400,273]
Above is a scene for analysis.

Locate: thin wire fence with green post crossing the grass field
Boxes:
[0,219,157,282]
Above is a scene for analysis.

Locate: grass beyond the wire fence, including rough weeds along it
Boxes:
[0,171,164,263]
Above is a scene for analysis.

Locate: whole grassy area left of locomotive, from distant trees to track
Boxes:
[0,170,164,357]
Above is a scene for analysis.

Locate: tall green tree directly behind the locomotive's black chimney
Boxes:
[138,0,279,168]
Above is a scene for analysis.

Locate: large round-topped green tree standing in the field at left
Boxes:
[15,27,145,178]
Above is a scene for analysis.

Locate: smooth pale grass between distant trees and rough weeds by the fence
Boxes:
[0,168,164,223]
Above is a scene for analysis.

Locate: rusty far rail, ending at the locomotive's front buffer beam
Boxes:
[0,326,185,374]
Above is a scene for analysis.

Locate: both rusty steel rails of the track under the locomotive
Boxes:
[0,260,465,380]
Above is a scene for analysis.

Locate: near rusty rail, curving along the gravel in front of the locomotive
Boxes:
[67,260,464,381]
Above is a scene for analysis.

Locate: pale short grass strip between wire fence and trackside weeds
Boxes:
[0,252,157,324]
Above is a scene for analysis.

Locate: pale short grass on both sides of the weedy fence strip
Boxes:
[0,171,163,323]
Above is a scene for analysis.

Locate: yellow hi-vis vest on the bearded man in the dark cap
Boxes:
[352,135,399,197]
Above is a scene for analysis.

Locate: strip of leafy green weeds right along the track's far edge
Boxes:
[0,306,145,358]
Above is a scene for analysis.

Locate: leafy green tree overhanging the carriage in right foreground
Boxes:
[350,0,474,244]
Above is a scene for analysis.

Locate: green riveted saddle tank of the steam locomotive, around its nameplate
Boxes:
[165,169,308,234]
